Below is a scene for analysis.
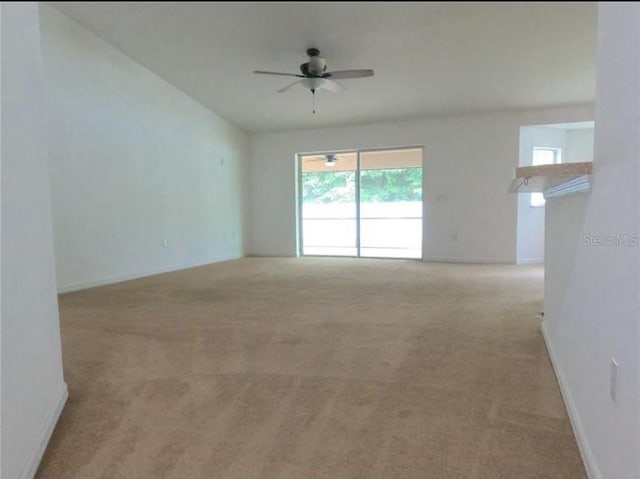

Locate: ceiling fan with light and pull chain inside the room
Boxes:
[253,48,373,113]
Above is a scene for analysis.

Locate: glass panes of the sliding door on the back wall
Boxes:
[299,148,422,258]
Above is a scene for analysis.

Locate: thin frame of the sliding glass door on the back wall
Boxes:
[295,145,424,260]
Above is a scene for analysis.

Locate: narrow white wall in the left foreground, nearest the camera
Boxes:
[0,2,67,479]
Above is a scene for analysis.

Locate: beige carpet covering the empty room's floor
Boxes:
[37,258,585,479]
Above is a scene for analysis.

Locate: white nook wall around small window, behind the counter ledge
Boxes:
[517,126,567,263]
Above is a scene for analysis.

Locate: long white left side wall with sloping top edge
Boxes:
[41,6,248,290]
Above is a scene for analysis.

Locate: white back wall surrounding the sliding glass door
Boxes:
[250,104,593,263]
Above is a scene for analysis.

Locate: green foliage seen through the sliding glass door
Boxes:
[302,168,422,203]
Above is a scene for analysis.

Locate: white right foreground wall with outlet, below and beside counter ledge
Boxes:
[544,3,640,479]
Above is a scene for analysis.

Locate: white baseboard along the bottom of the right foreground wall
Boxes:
[542,321,603,479]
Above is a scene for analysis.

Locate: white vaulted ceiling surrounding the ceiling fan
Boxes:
[47,2,596,132]
